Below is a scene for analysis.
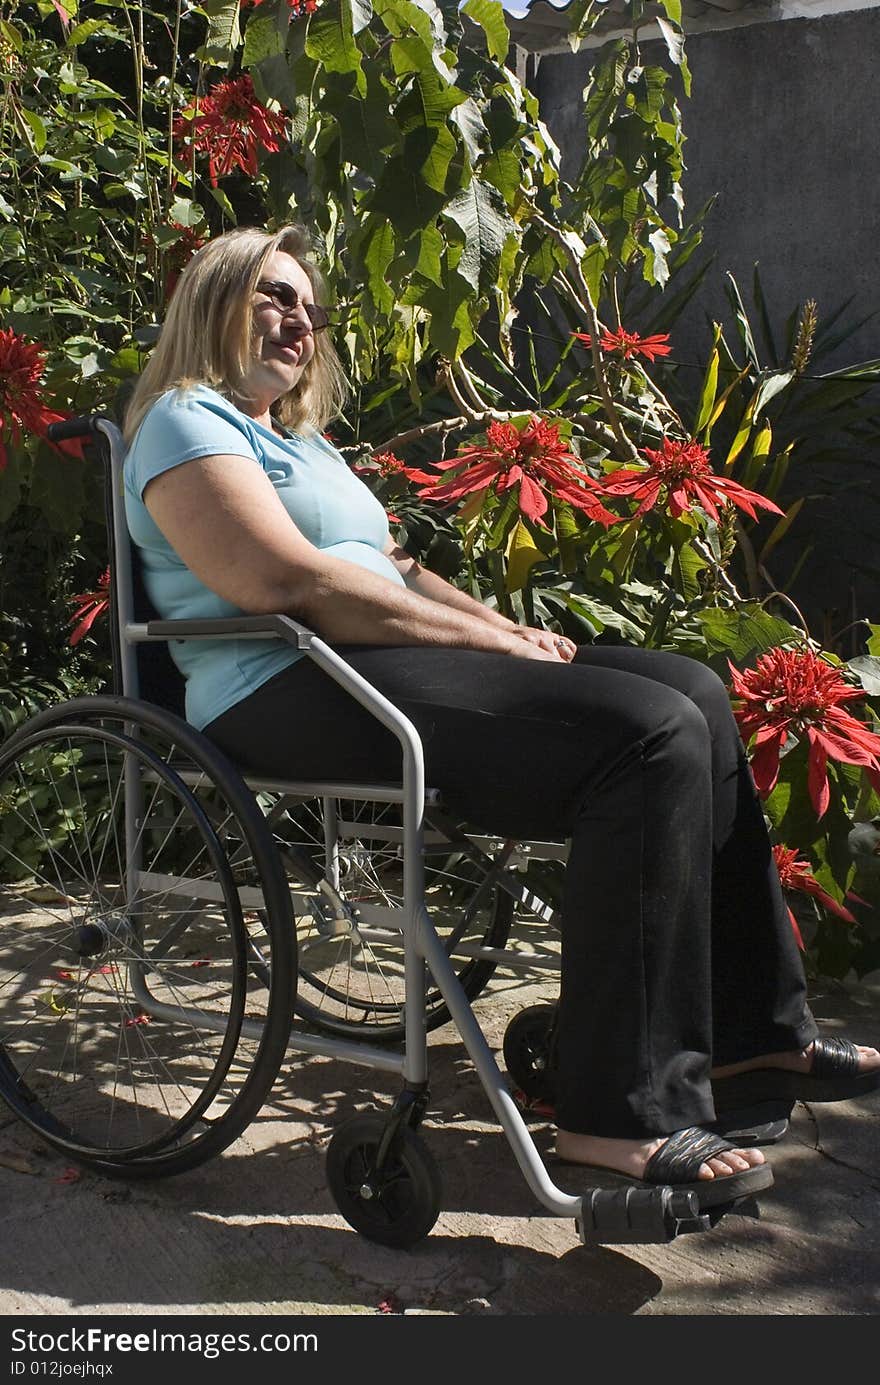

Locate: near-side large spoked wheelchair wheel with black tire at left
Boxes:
[0,698,295,1177]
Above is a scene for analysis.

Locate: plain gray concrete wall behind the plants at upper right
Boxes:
[532,8,880,636]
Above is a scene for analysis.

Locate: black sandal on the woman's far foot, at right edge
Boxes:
[712,1039,880,1114]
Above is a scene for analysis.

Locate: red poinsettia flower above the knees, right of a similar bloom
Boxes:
[601,438,783,519]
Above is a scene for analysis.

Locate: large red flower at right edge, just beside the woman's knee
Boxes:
[728,648,880,817]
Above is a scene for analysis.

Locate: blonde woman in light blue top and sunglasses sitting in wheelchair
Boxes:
[125,227,880,1206]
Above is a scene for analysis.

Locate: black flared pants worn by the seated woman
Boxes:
[206,645,816,1138]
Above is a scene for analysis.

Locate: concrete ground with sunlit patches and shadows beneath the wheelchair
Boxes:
[0,978,880,1317]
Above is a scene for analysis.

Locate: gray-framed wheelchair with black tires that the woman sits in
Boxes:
[0,414,721,1248]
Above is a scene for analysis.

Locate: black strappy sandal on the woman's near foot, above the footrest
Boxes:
[558,1126,773,1210]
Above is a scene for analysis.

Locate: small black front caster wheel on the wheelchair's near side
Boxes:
[327,1112,441,1249]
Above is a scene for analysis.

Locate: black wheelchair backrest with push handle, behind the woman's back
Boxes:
[94,418,184,716]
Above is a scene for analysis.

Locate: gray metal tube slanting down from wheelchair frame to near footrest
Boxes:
[419,910,581,1219]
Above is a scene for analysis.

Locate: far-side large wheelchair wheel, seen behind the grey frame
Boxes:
[273,799,513,1043]
